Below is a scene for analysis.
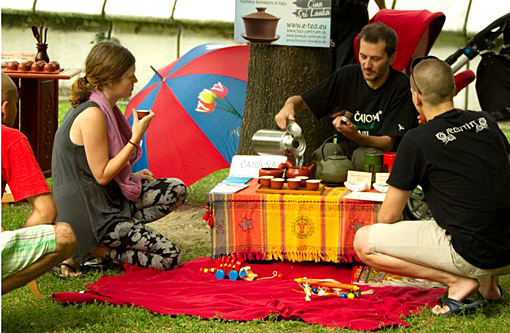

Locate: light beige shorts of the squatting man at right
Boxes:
[368,220,510,280]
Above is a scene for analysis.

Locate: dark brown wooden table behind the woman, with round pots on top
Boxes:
[2,68,81,177]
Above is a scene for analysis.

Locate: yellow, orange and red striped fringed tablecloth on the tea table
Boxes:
[208,179,380,262]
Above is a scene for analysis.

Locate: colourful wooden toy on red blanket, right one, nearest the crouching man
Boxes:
[292,277,374,301]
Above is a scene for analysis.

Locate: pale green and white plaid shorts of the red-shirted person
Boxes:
[0,224,56,281]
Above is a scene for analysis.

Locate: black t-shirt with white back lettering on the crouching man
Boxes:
[388,110,510,269]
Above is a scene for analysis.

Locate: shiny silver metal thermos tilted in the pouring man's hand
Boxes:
[251,129,306,157]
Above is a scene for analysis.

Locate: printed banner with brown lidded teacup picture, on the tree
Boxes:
[234,0,331,47]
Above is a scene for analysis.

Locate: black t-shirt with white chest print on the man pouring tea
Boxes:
[302,65,418,148]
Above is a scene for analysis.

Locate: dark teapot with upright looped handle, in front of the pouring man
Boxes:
[317,137,354,184]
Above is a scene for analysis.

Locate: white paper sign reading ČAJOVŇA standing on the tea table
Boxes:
[229,155,287,178]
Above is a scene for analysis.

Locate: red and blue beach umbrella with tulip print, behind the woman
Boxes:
[126,44,249,185]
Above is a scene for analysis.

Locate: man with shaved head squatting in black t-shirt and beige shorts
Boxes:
[354,59,510,315]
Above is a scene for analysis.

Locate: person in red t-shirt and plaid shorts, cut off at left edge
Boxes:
[1,73,76,295]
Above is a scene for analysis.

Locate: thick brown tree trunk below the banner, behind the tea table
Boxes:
[237,44,333,165]
